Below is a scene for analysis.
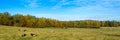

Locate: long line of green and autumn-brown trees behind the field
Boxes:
[0,12,120,28]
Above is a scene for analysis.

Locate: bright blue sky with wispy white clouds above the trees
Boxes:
[0,0,120,20]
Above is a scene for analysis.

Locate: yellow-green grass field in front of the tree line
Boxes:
[0,26,120,40]
